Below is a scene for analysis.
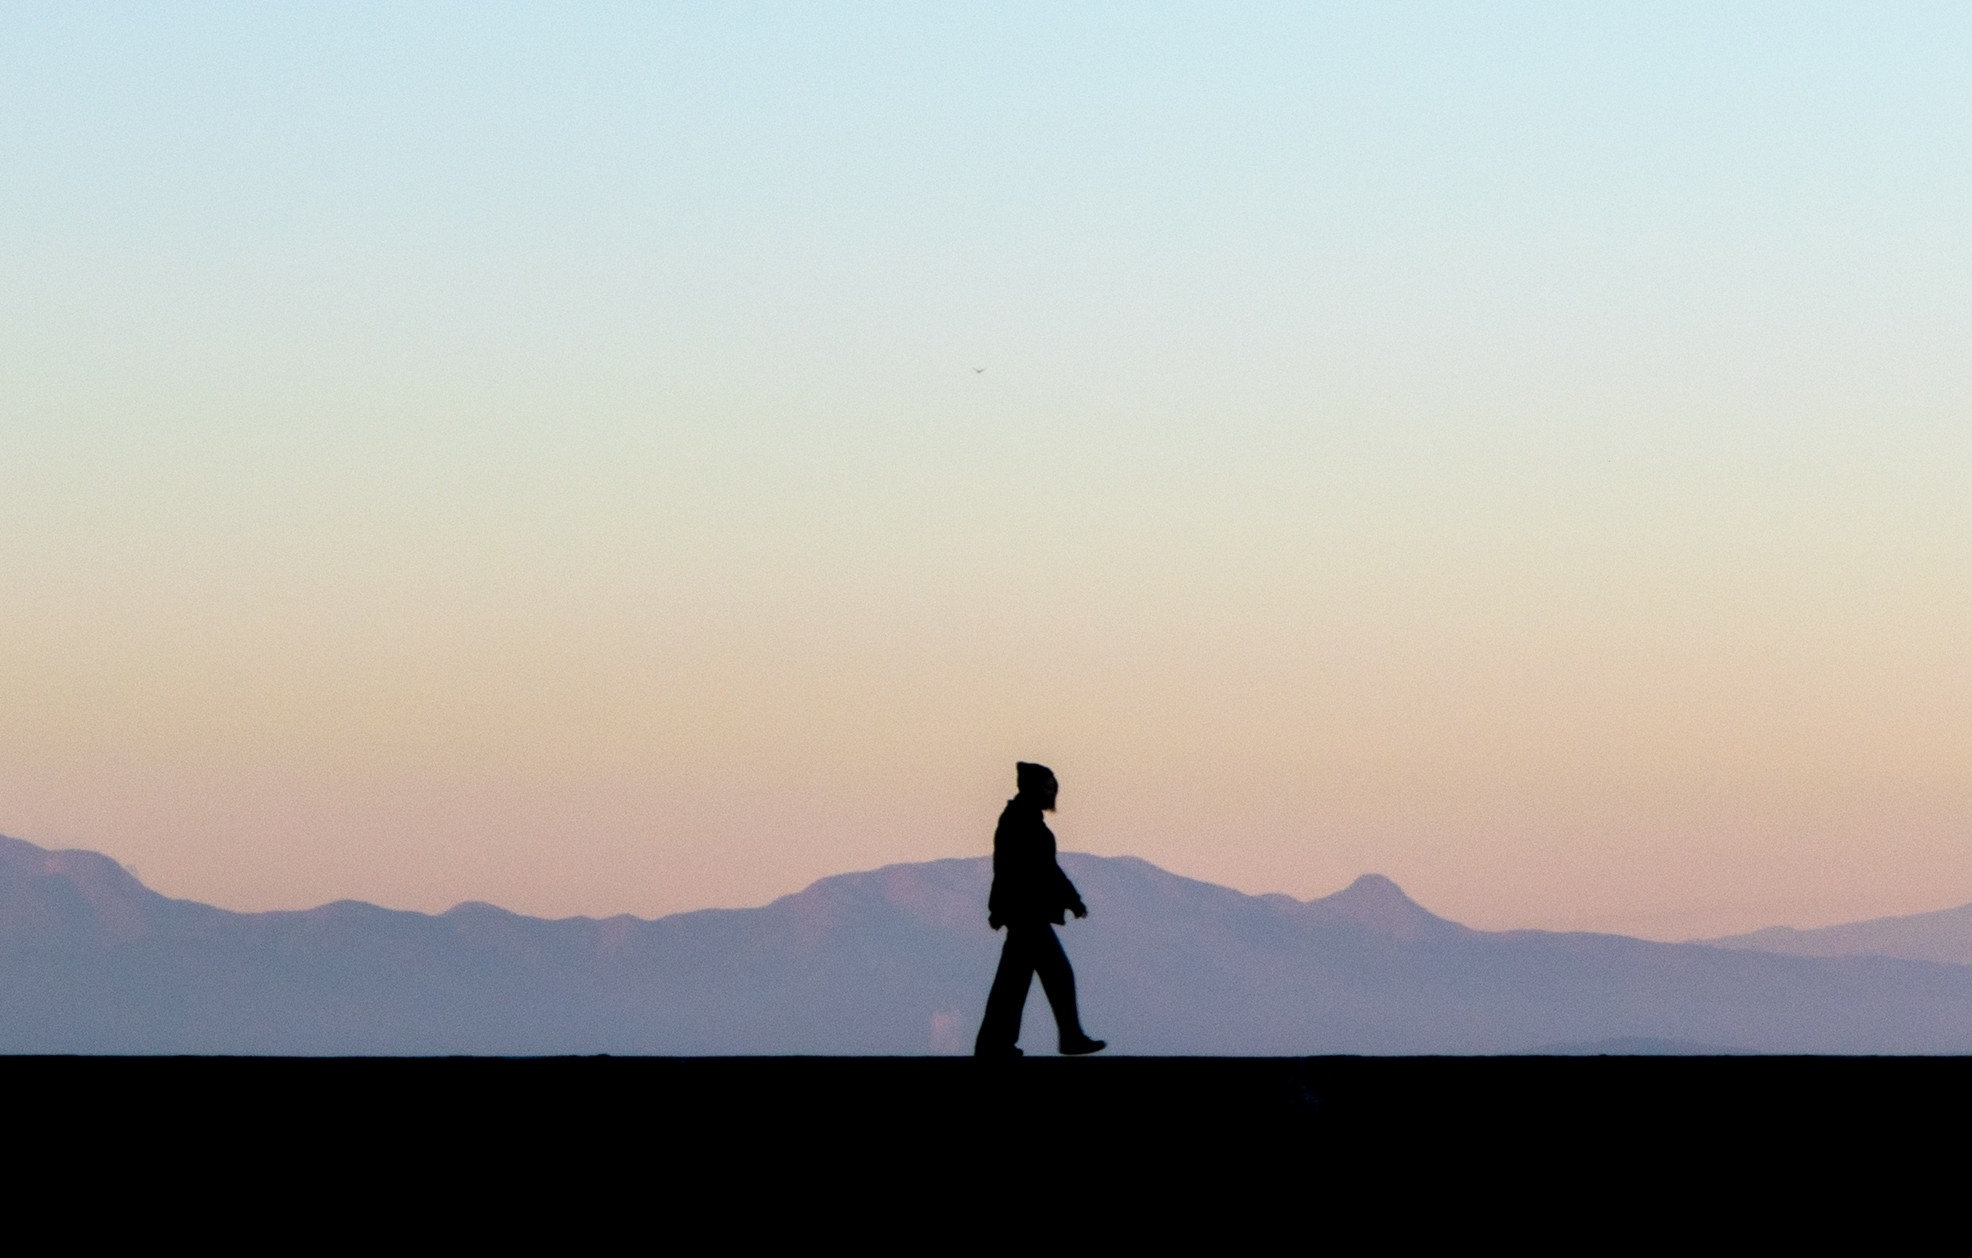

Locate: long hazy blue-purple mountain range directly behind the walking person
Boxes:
[11,838,1972,1055]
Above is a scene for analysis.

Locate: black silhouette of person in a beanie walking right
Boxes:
[972,761,1104,1057]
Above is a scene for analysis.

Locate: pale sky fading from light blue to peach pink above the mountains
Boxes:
[0,0,1972,939]
